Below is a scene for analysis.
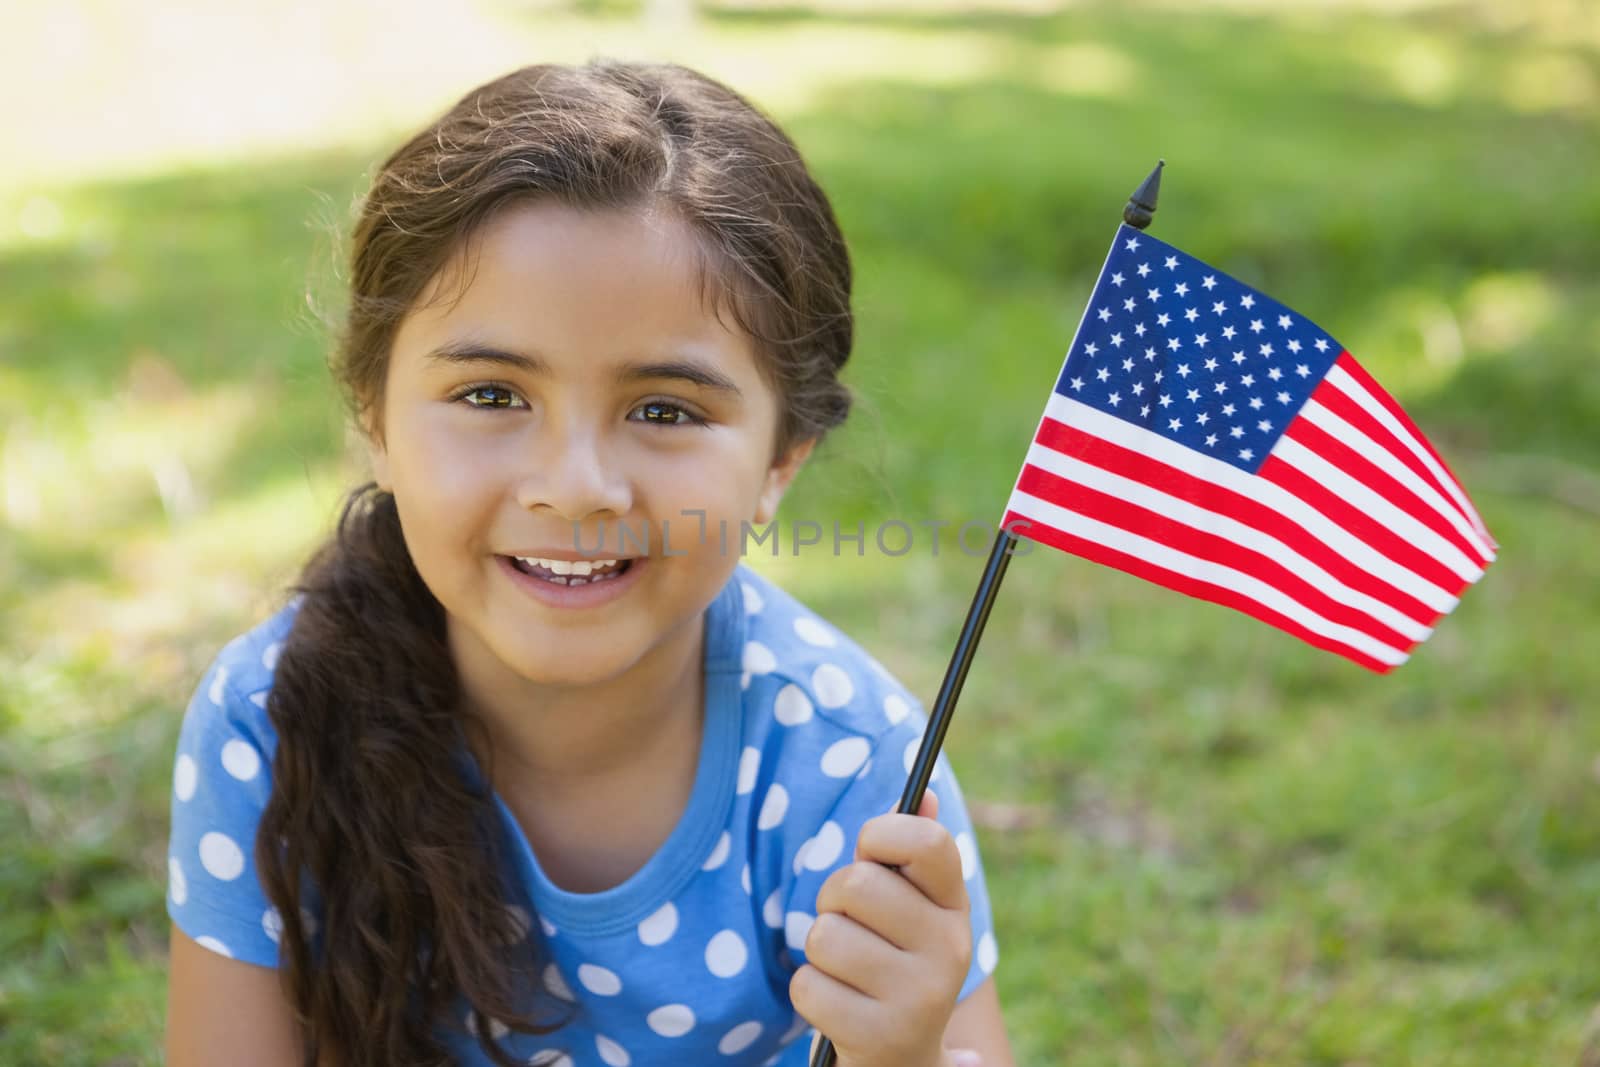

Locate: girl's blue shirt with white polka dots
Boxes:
[166,565,998,1067]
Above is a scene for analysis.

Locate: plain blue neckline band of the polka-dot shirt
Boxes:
[469,565,744,936]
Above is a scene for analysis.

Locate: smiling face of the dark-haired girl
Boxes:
[373,203,810,685]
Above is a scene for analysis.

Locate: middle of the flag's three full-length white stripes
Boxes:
[1027,445,1434,641]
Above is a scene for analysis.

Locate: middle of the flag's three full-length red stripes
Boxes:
[1018,464,1416,651]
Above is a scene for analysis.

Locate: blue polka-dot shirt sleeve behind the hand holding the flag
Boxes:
[784,720,1000,1004]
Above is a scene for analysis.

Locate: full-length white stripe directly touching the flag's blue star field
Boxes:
[1045,392,1459,614]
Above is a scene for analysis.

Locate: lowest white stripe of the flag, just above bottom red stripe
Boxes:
[1008,491,1406,665]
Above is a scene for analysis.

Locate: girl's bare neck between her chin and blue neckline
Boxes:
[450,614,706,798]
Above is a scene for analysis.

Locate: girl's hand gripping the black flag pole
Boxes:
[789,790,973,1067]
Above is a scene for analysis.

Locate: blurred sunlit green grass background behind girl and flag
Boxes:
[0,0,1600,1067]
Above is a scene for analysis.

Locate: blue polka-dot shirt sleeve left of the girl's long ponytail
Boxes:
[166,649,294,968]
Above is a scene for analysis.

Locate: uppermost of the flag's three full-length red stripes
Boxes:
[1035,418,1440,625]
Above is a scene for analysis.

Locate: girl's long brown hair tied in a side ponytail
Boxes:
[256,61,853,1067]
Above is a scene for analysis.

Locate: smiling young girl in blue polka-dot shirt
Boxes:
[168,62,1011,1067]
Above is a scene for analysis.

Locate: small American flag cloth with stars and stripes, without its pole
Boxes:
[1005,226,1496,672]
